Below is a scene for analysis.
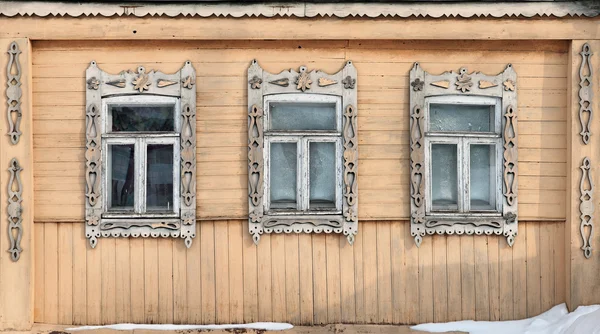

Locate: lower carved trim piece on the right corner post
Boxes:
[579,157,594,259]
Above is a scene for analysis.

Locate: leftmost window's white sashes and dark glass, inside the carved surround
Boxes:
[102,95,180,218]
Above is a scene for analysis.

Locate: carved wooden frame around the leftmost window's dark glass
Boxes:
[85,61,196,248]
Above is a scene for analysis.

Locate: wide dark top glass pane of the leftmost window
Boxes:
[109,105,175,132]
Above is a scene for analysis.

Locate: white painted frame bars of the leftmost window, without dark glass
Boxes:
[101,95,181,221]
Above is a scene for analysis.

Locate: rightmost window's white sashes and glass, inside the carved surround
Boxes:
[425,96,502,216]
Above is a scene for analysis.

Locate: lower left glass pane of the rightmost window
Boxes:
[431,144,458,210]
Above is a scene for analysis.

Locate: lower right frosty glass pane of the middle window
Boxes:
[309,143,336,209]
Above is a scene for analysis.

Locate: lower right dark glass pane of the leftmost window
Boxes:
[146,144,173,211]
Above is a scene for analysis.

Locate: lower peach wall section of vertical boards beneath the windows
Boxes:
[35,220,566,324]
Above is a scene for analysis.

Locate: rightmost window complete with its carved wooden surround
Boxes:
[410,64,517,245]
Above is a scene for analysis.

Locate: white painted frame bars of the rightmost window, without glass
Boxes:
[425,95,503,219]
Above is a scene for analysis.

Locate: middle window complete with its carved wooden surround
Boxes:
[248,61,358,243]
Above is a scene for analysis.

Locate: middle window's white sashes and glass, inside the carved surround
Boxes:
[264,94,343,215]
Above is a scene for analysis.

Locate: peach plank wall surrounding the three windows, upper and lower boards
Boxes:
[32,41,569,324]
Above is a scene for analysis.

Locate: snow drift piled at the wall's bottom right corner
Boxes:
[411,304,600,334]
